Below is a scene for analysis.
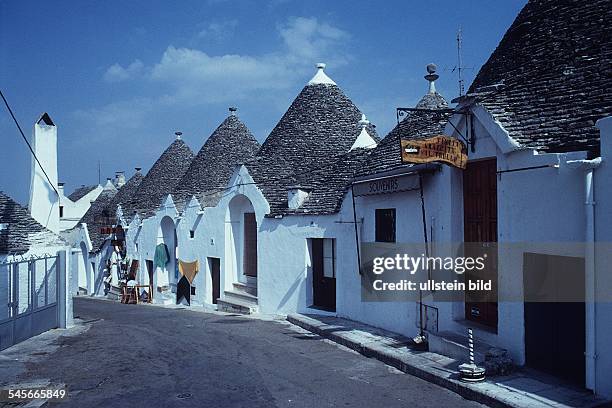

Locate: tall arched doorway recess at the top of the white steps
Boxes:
[225,195,257,292]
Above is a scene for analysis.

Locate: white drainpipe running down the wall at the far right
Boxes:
[567,157,601,393]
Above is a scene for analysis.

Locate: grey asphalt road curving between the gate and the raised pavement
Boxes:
[11,298,482,408]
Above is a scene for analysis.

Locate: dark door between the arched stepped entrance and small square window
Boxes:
[311,238,336,311]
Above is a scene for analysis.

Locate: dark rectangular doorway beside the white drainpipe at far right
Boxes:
[523,253,586,387]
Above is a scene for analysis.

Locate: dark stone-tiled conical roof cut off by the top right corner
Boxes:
[468,0,612,156]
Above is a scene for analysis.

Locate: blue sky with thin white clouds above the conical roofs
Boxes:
[0,0,525,203]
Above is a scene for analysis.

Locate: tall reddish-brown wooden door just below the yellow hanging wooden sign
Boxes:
[463,159,497,329]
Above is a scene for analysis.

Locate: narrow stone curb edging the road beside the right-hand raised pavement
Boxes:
[287,314,524,408]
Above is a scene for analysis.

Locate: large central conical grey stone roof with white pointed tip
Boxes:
[246,65,378,216]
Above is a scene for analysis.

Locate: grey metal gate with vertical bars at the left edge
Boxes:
[0,255,60,350]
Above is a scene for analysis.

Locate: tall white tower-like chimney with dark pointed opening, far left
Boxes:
[29,113,59,233]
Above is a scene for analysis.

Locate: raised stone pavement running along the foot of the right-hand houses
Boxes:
[287,314,606,408]
